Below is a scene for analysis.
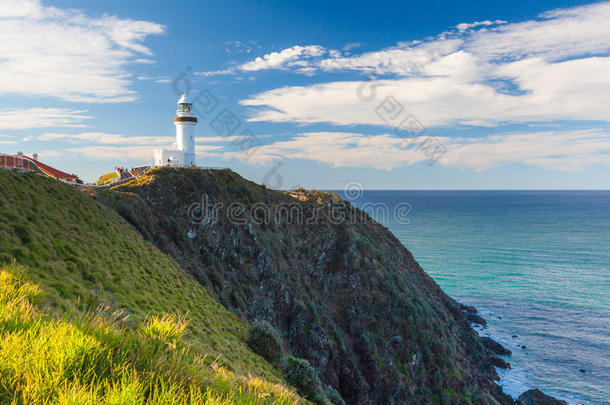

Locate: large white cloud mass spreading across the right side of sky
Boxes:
[242,2,610,127]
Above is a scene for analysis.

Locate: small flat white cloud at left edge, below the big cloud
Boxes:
[0,108,91,129]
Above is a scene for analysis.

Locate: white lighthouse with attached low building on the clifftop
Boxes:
[155,93,197,167]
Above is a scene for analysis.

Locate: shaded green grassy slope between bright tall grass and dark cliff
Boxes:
[0,170,302,402]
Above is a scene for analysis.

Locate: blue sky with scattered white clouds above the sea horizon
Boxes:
[0,0,610,189]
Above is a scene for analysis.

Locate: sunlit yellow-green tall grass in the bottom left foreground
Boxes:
[0,265,301,405]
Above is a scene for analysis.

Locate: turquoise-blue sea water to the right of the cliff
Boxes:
[339,191,610,404]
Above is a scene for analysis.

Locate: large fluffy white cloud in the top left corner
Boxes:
[0,0,164,102]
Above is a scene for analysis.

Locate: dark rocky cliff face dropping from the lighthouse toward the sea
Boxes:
[98,168,512,404]
